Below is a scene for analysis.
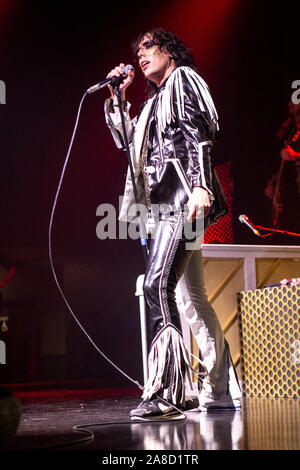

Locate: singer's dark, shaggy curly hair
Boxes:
[131,28,197,95]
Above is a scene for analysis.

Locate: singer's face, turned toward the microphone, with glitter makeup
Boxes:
[137,34,175,86]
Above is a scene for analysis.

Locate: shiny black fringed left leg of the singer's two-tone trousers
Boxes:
[143,212,199,404]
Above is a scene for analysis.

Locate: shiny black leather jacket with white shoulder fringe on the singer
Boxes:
[107,67,227,224]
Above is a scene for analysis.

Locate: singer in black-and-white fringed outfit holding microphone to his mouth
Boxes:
[105,28,241,421]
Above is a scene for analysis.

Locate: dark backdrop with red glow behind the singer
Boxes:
[0,0,300,387]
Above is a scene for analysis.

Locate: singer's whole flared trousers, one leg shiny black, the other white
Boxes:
[143,213,240,405]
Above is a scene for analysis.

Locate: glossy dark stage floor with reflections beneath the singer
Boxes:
[2,389,300,451]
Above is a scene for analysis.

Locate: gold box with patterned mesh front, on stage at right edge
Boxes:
[238,286,300,398]
